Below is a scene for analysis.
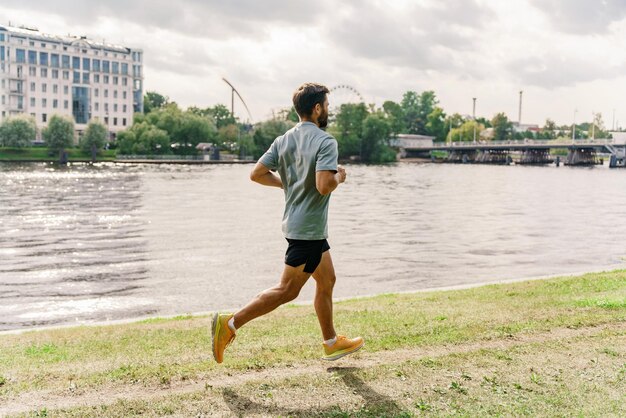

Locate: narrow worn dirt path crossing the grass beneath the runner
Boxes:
[0,322,626,416]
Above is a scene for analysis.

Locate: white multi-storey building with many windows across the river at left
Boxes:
[0,25,143,140]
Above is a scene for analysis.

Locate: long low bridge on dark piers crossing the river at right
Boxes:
[393,139,626,167]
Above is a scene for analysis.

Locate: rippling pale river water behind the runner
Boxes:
[0,163,626,330]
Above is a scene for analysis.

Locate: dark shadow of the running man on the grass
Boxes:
[222,367,411,418]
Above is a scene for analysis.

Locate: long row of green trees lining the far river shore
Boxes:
[0,91,610,163]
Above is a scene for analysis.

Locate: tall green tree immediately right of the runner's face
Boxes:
[328,103,369,158]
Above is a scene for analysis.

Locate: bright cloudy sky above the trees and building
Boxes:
[0,0,626,128]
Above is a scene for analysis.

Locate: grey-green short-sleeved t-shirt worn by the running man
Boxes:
[259,122,338,240]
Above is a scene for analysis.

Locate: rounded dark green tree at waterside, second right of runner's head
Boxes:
[361,112,396,163]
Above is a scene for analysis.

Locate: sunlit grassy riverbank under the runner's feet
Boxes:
[0,270,626,417]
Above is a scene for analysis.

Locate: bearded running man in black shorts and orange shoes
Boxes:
[211,83,364,363]
